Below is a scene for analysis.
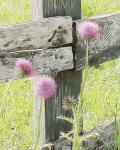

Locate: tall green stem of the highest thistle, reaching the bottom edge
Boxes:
[72,40,89,150]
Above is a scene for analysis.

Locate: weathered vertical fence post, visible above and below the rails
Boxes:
[31,0,81,148]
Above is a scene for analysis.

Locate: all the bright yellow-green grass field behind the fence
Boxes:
[0,0,120,150]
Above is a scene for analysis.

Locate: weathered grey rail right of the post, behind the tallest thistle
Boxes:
[74,13,120,70]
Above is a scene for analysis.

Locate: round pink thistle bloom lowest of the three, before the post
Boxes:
[35,75,56,99]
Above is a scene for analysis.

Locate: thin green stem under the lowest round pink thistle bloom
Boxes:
[34,99,42,150]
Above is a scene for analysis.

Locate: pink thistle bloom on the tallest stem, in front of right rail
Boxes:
[77,21,99,40]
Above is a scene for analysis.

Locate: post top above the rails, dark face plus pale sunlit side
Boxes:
[30,0,81,20]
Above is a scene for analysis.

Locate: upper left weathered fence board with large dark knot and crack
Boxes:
[0,17,72,53]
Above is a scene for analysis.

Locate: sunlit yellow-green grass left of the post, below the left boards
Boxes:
[0,79,33,150]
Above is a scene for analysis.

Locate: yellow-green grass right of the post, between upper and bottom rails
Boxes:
[84,59,120,128]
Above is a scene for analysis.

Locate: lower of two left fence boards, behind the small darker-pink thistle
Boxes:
[0,47,74,82]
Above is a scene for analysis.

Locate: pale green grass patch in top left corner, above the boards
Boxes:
[0,0,31,24]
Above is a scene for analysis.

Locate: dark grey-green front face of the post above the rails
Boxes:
[43,0,81,19]
